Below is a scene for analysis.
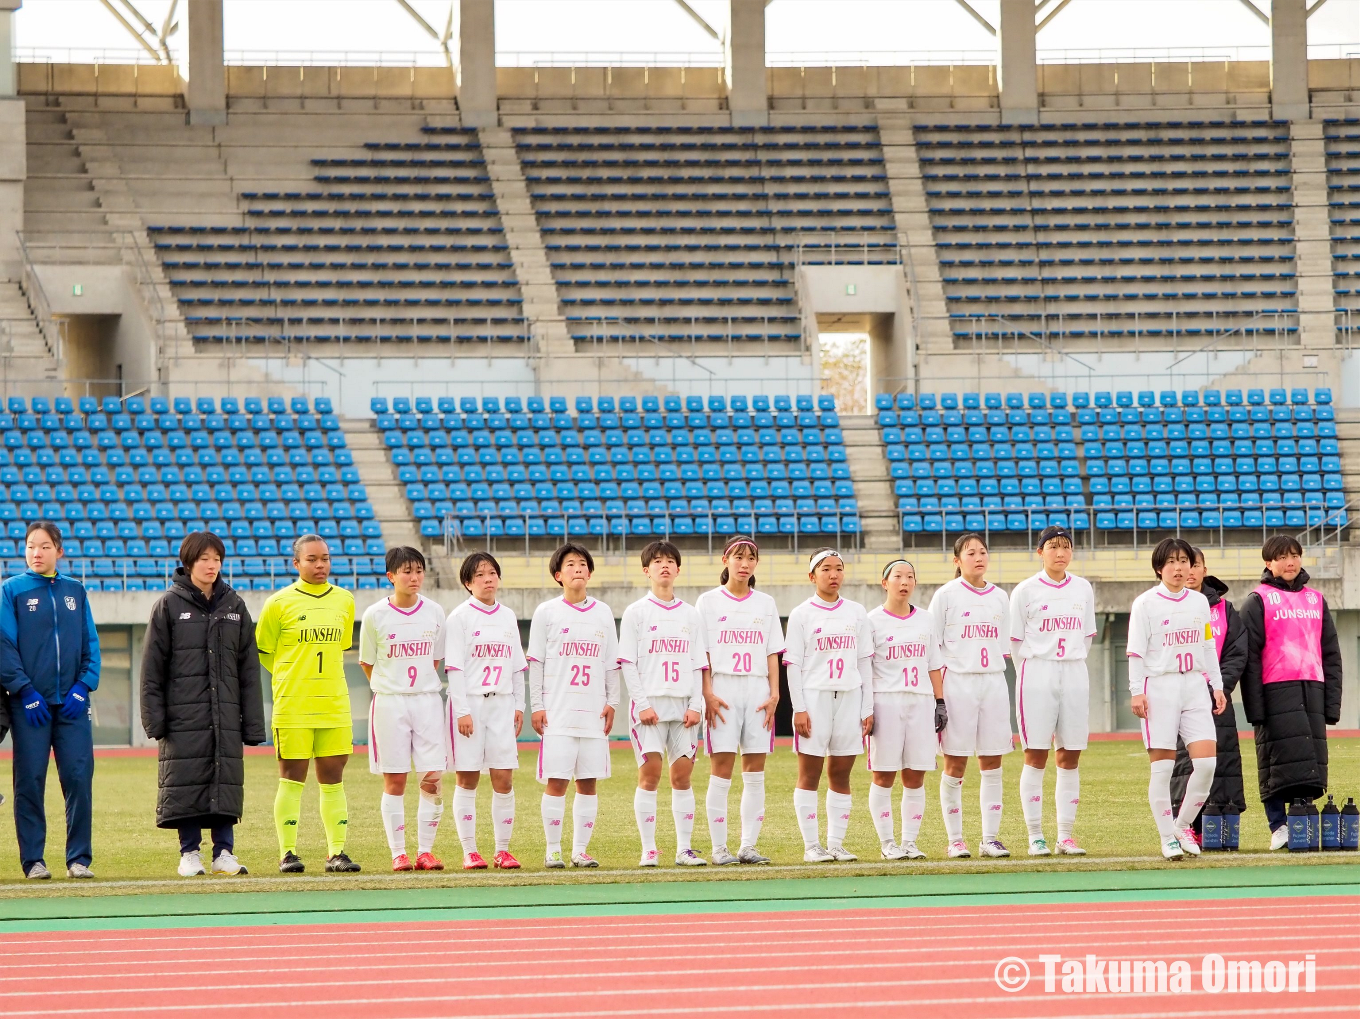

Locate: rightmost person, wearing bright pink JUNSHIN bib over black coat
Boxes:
[1242,535,1341,849]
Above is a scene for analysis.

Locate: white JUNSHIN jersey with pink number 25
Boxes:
[528,597,619,739]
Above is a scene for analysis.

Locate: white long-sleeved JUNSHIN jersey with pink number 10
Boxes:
[1127,584,1223,682]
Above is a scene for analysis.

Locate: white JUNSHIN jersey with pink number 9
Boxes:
[359,599,445,694]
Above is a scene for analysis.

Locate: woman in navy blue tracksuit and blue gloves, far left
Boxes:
[0,521,99,878]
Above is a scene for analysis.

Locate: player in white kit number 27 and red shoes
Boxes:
[443,552,529,871]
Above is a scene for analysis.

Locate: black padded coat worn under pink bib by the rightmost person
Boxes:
[1242,570,1341,800]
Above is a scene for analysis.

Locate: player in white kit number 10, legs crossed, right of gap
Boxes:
[1129,537,1228,860]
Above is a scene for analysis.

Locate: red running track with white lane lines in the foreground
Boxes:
[0,897,1360,1019]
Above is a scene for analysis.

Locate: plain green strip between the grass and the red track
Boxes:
[0,865,1360,935]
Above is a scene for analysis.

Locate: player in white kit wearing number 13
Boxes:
[868,559,949,860]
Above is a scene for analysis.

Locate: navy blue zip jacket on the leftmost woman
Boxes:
[0,570,99,706]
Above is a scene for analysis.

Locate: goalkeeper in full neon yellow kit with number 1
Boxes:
[256,535,359,873]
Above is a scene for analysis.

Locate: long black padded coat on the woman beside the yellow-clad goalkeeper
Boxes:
[141,566,267,829]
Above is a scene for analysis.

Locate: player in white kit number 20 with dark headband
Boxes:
[695,535,783,867]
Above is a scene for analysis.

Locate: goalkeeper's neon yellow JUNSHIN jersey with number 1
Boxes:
[256,581,354,729]
